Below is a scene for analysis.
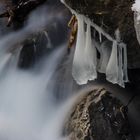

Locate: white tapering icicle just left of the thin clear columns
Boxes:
[106,41,119,84]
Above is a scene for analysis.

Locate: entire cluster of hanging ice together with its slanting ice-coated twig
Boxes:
[61,0,128,87]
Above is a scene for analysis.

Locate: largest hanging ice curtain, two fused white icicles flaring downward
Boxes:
[72,14,97,85]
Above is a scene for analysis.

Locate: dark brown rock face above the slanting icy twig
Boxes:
[66,0,140,68]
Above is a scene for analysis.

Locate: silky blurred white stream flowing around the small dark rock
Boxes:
[0,3,76,140]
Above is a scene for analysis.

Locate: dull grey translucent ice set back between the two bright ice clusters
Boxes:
[98,41,112,73]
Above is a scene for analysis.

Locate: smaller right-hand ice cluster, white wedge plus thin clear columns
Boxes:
[106,41,128,87]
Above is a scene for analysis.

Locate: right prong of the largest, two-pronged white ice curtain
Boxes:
[85,21,97,80]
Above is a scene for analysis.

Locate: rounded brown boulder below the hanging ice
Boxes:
[64,89,135,140]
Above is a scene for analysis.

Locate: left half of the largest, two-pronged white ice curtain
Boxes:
[72,14,87,85]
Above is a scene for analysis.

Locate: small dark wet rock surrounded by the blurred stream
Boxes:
[18,31,50,69]
